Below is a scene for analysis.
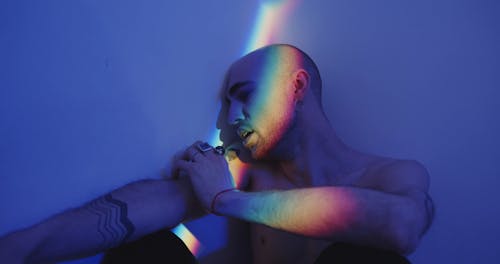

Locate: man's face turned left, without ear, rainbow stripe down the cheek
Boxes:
[221,49,295,159]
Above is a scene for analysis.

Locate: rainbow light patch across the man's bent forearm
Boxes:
[247,186,362,238]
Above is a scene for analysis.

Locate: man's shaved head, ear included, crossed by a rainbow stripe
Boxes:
[217,44,322,158]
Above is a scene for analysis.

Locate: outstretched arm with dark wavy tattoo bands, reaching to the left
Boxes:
[0,179,203,263]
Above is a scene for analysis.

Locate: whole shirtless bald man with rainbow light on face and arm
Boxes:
[0,45,433,263]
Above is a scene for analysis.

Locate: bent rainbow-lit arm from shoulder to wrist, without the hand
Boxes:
[214,162,433,254]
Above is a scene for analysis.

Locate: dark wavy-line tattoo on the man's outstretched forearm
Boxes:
[86,194,135,248]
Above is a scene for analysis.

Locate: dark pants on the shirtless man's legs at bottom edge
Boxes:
[101,230,410,264]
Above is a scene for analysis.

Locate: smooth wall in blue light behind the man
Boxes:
[0,0,500,263]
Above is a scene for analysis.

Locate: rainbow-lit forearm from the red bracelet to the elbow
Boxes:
[215,187,419,253]
